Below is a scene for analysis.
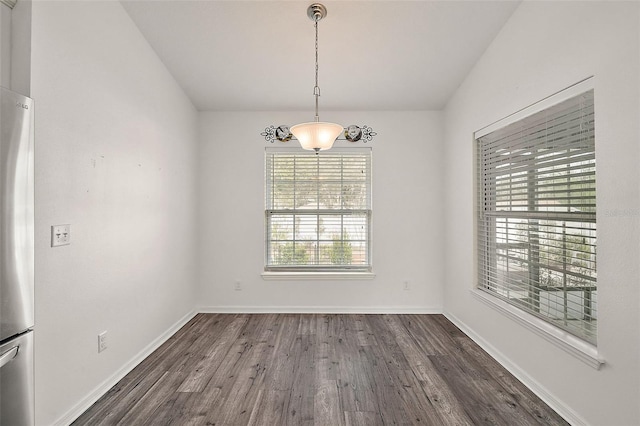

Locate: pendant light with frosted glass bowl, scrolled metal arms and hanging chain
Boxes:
[261,3,376,153]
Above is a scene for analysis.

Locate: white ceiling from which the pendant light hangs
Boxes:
[121,0,519,111]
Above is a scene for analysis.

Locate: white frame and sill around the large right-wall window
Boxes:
[471,77,604,369]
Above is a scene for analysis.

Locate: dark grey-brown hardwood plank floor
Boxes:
[73,314,567,426]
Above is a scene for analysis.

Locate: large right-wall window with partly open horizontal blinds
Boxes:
[476,85,597,344]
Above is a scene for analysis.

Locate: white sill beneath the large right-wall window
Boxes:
[471,289,604,370]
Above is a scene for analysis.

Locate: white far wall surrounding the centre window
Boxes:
[198,112,443,312]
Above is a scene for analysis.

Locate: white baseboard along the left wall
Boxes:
[54,310,197,426]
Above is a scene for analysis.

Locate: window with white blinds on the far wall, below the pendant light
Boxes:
[265,148,371,272]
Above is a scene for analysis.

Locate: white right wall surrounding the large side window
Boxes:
[444,2,640,426]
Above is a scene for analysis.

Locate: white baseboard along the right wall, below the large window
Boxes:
[444,311,588,426]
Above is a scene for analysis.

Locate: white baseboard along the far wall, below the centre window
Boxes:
[198,306,442,314]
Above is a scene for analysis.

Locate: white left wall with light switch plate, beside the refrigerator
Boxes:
[31,1,197,425]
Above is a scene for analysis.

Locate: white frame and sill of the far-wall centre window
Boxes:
[262,147,375,280]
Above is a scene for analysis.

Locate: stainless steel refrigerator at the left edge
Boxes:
[0,88,34,426]
